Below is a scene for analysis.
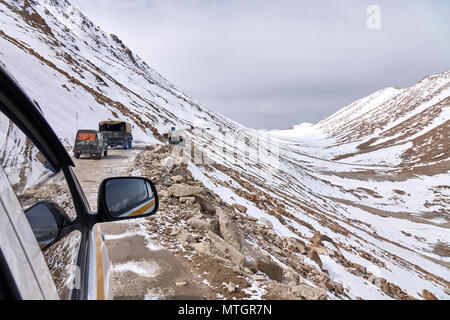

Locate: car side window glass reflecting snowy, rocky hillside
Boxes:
[0,112,81,299]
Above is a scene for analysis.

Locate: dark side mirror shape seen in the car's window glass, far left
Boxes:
[25,200,71,250]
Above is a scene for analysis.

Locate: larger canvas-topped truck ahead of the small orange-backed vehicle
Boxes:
[98,121,133,149]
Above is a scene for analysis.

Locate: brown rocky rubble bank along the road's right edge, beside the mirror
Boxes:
[131,146,400,299]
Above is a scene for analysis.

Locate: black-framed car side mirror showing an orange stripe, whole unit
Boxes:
[98,177,159,221]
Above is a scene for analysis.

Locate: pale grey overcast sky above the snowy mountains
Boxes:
[69,0,450,129]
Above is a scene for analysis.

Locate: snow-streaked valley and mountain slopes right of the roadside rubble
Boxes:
[184,71,450,299]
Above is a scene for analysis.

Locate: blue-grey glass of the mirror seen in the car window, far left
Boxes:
[25,202,59,249]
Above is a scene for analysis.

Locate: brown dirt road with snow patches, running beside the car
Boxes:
[74,148,208,299]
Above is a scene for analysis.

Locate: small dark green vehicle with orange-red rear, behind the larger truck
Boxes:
[73,129,108,160]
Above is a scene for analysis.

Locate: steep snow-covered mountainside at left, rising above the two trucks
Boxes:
[0,0,239,145]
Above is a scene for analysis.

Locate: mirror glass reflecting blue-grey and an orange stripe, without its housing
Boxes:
[105,178,155,218]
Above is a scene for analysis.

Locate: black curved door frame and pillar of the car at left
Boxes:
[0,66,98,300]
